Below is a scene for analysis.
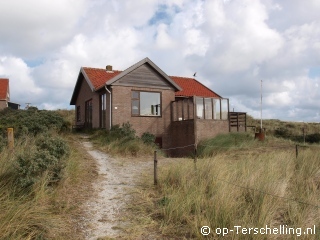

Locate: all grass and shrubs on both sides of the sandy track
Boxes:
[0,108,320,240]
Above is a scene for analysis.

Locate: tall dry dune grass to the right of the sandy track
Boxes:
[131,136,320,239]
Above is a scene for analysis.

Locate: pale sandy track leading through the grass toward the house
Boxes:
[81,139,153,240]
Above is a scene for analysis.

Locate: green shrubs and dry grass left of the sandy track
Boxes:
[0,108,93,240]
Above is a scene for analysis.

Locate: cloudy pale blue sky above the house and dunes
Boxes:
[0,0,320,122]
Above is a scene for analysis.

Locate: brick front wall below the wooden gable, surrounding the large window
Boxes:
[111,86,175,148]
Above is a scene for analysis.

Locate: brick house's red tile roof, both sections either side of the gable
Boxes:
[83,67,221,97]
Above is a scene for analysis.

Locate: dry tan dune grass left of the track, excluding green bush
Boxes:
[0,135,93,240]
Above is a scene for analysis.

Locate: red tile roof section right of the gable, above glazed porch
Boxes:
[170,76,221,98]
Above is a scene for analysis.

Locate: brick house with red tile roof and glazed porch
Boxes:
[70,58,245,155]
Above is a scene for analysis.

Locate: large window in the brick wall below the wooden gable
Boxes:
[131,91,161,116]
